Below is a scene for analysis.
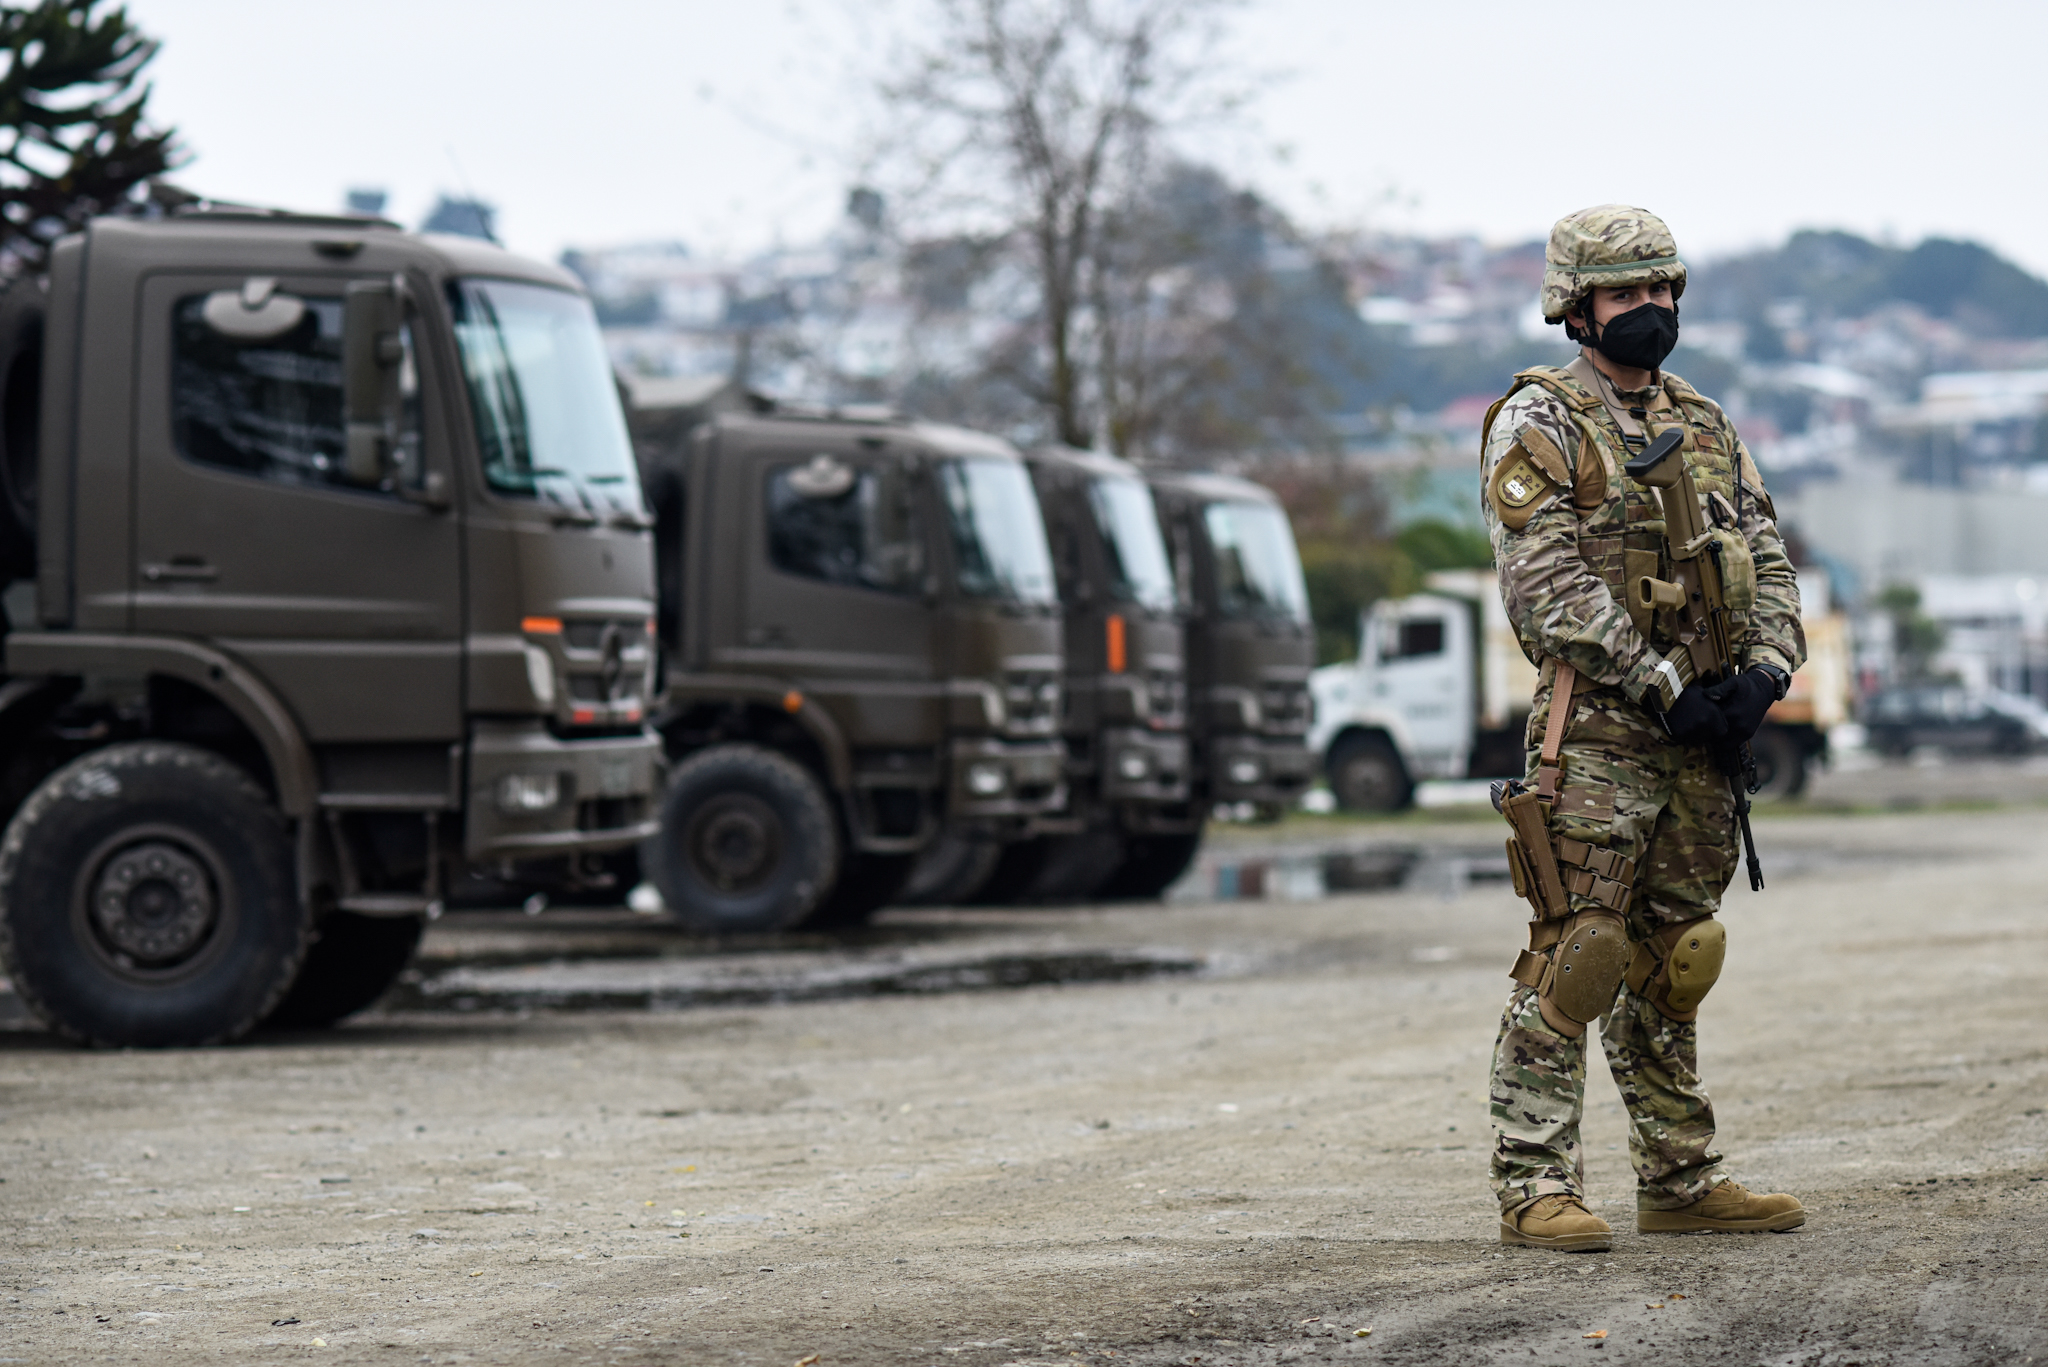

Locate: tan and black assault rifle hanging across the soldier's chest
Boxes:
[1622,426,1763,892]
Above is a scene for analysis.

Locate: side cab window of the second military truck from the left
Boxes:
[768,457,924,592]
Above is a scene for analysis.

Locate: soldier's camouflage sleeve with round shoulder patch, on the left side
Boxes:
[1481,385,1663,701]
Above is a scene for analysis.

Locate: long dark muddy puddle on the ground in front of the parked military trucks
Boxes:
[383,949,1210,1012]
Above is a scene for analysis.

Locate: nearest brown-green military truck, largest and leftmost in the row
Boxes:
[0,203,662,1045]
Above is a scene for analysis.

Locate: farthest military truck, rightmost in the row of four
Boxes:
[1146,469,1315,848]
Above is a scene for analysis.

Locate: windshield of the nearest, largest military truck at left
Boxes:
[449,279,641,508]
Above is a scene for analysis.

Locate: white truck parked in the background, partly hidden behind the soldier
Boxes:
[1309,570,1849,812]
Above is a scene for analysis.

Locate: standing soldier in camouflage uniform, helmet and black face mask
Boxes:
[1483,205,1806,1252]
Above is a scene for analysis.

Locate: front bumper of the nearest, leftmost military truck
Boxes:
[463,721,662,863]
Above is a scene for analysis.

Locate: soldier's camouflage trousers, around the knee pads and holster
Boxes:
[1489,689,1739,1209]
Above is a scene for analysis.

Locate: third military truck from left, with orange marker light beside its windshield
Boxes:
[907,447,1202,904]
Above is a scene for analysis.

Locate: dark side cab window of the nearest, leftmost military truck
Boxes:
[170,295,422,488]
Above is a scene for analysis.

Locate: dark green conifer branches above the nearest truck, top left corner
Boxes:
[0,0,176,275]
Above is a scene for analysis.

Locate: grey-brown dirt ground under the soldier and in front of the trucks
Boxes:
[0,810,2048,1367]
